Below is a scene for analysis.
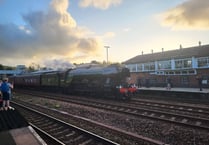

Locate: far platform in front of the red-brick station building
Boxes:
[138,87,209,104]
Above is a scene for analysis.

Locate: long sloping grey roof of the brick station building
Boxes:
[124,45,209,64]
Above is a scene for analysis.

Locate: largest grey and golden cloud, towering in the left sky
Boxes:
[0,0,103,63]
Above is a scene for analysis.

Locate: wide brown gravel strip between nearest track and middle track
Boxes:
[16,96,209,145]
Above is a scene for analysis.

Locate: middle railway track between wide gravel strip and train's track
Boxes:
[62,98,209,131]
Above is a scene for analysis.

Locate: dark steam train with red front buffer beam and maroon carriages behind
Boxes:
[10,65,136,99]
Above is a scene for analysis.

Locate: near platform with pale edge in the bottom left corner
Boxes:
[0,109,46,145]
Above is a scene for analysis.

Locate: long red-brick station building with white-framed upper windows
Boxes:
[124,42,209,88]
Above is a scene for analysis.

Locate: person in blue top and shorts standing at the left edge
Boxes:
[0,78,14,110]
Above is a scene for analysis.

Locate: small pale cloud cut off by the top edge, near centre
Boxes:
[79,0,122,10]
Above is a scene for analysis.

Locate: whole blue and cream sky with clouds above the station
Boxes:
[0,0,209,67]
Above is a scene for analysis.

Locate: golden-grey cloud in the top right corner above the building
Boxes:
[161,0,209,29]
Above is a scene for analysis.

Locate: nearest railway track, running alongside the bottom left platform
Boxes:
[13,102,118,145]
